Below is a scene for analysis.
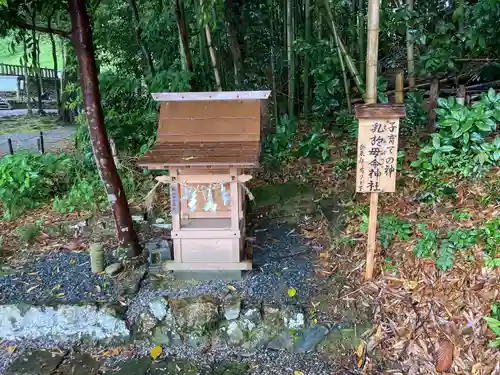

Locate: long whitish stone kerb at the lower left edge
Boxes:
[0,305,130,343]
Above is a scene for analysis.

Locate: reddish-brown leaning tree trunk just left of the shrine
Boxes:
[68,0,141,256]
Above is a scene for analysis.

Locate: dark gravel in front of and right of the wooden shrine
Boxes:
[127,225,320,322]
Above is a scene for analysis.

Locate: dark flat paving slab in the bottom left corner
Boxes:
[4,349,67,375]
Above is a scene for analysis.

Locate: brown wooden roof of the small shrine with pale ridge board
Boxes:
[138,91,270,169]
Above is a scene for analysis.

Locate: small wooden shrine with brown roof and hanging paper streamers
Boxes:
[138,91,270,271]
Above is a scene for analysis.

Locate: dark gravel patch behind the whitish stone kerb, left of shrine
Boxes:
[0,251,117,304]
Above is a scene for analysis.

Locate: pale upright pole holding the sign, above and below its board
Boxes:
[365,0,380,280]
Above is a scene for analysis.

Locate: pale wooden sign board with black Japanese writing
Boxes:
[356,118,399,193]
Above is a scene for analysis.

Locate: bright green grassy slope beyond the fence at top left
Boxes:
[0,35,62,68]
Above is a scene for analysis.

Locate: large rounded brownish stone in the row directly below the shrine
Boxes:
[169,296,219,332]
